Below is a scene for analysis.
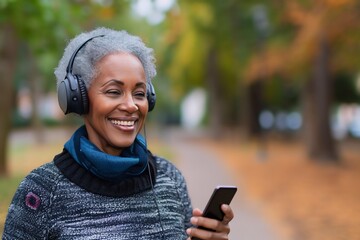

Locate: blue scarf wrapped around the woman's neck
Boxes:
[64,126,147,182]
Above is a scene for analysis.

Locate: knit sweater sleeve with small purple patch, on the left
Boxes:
[3,164,55,240]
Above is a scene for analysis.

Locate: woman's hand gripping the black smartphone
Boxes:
[186,204,234,240]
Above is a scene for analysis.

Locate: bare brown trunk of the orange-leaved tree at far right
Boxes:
[303,32,338,162]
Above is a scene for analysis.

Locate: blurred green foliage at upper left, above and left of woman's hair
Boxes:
[0,0,134,92]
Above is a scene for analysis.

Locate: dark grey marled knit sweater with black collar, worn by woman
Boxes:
[3,152,192,240]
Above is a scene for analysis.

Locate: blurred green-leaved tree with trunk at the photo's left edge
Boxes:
[0,0,129,175]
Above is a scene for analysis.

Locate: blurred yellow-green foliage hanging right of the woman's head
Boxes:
[160,1,253,95]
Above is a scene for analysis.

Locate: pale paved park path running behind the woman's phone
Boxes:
[160,129,280,240]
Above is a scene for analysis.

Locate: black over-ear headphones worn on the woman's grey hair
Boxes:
[57,35,156,115]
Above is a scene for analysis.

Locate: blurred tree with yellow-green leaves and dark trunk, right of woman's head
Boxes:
[160,0,251,136]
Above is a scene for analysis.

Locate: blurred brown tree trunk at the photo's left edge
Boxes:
[0,24,18,176]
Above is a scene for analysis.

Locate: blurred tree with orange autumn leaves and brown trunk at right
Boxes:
[246,0,360,161]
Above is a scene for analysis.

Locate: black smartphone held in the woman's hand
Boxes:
[191,186,237,240]
